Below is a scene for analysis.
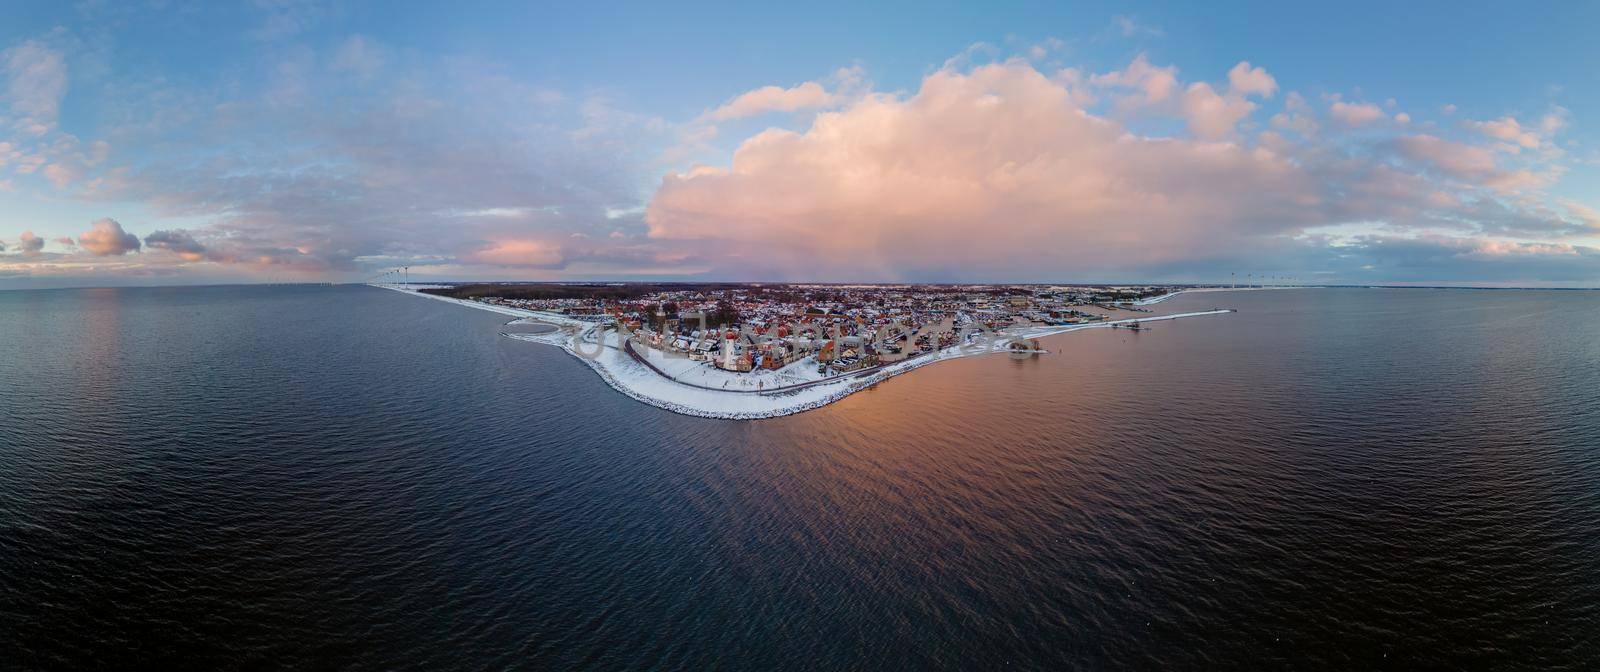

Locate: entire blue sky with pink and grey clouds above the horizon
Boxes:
[0,0,1600,288]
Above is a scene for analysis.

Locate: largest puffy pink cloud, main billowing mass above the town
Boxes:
[646,64,1318,277]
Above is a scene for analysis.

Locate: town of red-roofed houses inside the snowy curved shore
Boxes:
[457,285,1174,387]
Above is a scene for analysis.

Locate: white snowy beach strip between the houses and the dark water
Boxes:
[373,285,1232,419]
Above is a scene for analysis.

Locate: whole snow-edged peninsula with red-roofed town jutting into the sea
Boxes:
[374,283,1259,419]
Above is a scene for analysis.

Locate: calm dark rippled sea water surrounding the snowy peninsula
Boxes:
[0,286,1600,670]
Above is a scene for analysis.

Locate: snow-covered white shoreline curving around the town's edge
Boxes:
[370,285,1259,419]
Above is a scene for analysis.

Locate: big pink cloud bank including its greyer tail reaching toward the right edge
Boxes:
[645,61,1579,280]
